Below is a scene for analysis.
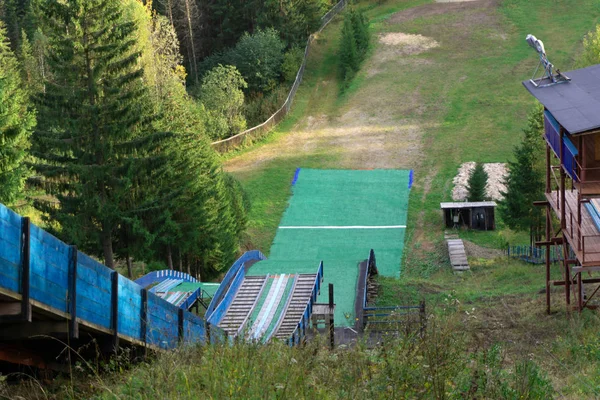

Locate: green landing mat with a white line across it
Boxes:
[248,169,411,326]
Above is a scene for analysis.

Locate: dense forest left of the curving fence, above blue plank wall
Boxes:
[0,0,331,278]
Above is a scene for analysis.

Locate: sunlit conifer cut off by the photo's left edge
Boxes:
[0,21,35,205]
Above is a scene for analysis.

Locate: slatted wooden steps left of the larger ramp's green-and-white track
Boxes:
[218,276,267,336]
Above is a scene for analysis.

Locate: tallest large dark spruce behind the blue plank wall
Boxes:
[34,0,165,268]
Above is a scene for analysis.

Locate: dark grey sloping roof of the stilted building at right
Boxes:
[523,64,600,134]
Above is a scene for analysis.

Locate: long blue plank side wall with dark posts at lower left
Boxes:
[0,204,224,349]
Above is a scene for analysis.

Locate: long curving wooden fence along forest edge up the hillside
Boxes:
[211,0,347,153]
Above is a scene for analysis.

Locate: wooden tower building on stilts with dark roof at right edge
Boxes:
[523,65,600,312]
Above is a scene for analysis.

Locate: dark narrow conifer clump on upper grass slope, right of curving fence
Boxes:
[339,7,370,89]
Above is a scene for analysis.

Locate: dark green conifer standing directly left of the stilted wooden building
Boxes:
[498,107,546,231]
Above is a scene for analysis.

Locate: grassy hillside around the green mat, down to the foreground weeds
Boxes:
[10,0,600,399]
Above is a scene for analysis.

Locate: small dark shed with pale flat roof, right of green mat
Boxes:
[440,201,497,231]
